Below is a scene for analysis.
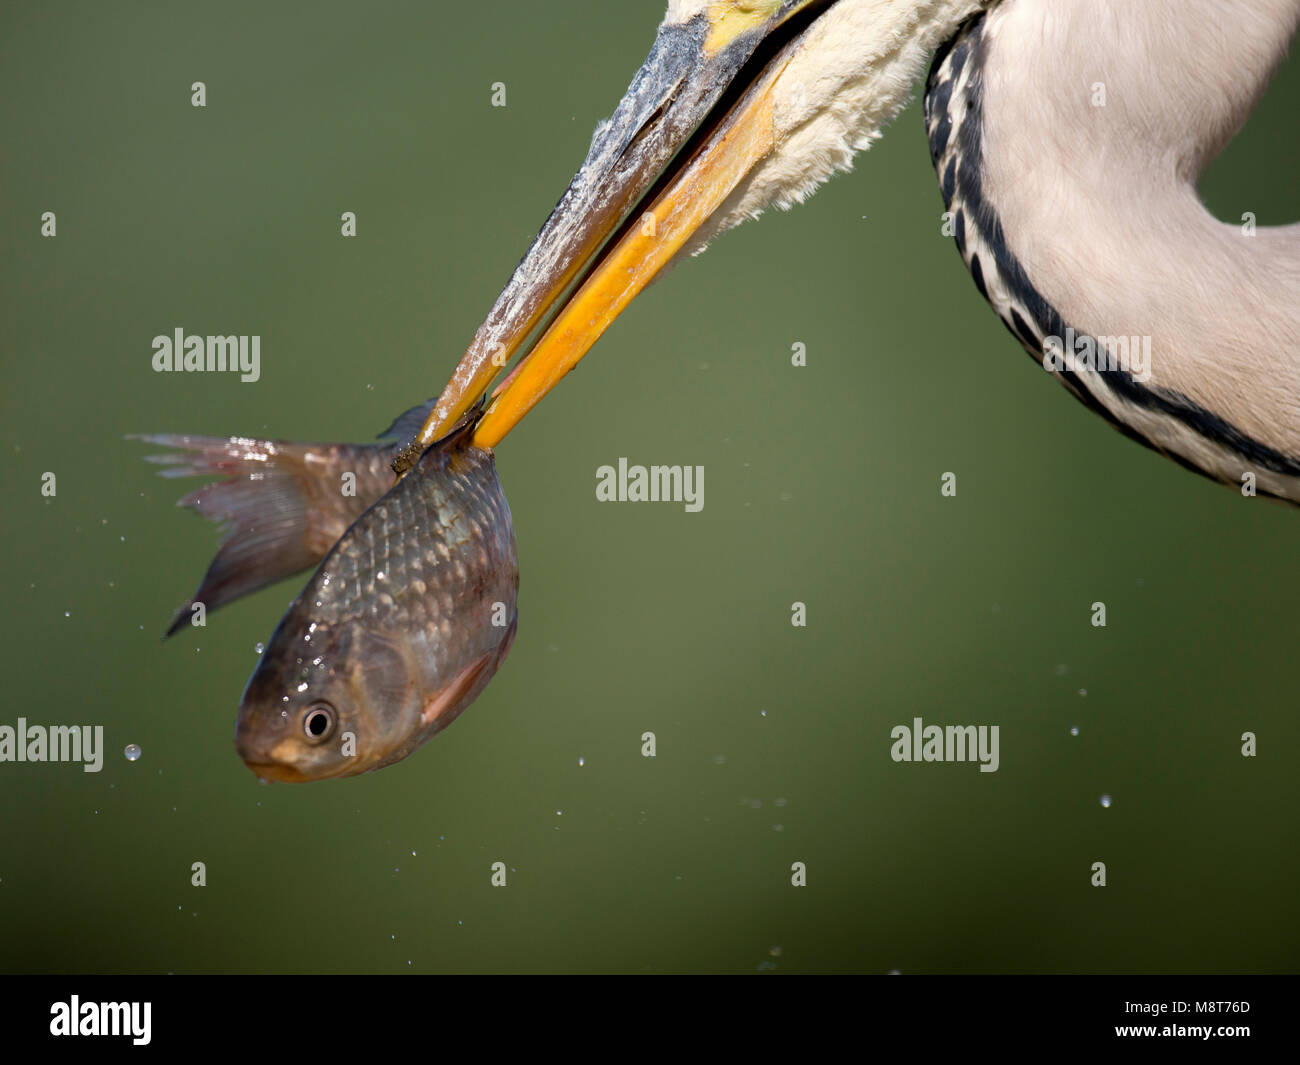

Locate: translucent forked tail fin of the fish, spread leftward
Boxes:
[127,433,393,638]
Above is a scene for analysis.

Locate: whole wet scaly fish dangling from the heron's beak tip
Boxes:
[137,402,519,783]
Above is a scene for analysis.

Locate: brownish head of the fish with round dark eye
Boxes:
[228,610,428,782]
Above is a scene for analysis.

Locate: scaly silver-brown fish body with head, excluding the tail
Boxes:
[235,425,519,782]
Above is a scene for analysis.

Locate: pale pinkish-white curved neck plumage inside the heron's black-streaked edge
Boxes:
[983,0,1300,455]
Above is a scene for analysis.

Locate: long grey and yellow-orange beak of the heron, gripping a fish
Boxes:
[394,0,835,473]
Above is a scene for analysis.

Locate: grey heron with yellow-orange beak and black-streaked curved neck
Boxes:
[394,0,1300,502]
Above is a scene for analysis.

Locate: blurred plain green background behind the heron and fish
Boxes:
[0,0,1300,973]
